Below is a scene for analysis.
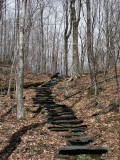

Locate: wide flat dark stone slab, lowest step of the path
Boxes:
[59,146,108,155]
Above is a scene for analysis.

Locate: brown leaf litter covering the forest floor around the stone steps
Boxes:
[0,62,120,160]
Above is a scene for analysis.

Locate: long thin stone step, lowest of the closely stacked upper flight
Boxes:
[48,126,86,132]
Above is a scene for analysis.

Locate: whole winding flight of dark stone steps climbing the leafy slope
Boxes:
[33,77,108,160]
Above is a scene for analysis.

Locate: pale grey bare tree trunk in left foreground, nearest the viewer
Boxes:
[17,0,27,119]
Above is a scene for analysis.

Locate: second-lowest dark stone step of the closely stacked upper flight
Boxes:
[52,119,83,125]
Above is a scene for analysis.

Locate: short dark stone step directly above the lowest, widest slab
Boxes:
[67,137,94,146]
